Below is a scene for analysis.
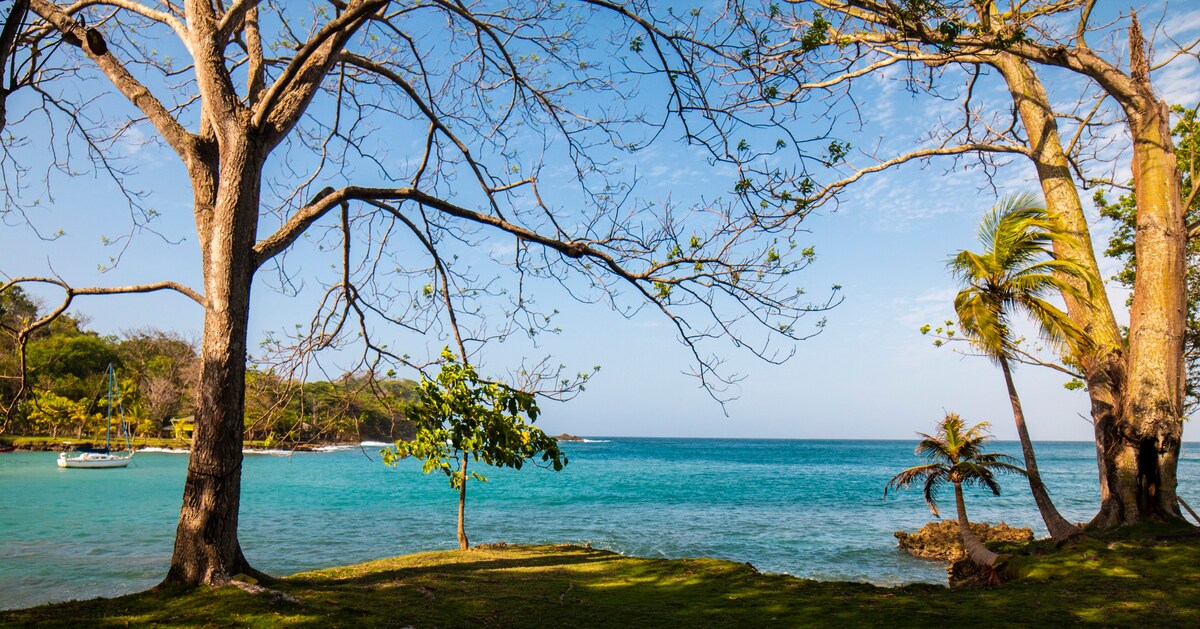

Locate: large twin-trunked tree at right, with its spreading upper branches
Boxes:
[772,0,1200,527]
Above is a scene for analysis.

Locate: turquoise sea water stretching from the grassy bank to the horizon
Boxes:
[0,437,1200,609]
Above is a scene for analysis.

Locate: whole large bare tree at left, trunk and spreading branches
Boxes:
[7,0,836,583]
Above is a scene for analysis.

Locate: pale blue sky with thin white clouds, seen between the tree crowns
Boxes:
[0,1,1200,441]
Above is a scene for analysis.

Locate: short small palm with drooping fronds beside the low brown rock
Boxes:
[883,413,1025,567]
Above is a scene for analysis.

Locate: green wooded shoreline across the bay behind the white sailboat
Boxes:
[0,287,415,448]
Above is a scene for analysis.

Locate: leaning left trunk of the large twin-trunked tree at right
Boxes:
[991,53,1126,525]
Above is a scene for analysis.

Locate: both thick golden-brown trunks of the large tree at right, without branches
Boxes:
[992,34,1187,527]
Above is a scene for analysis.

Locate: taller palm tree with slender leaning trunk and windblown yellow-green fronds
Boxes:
[949,194,1098,540]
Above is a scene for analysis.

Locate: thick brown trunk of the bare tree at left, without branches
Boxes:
[166,140,265,585]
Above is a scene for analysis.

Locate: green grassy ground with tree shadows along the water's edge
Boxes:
[0,532,1200,628]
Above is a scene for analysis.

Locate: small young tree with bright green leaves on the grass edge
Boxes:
[382,348,566,550]
